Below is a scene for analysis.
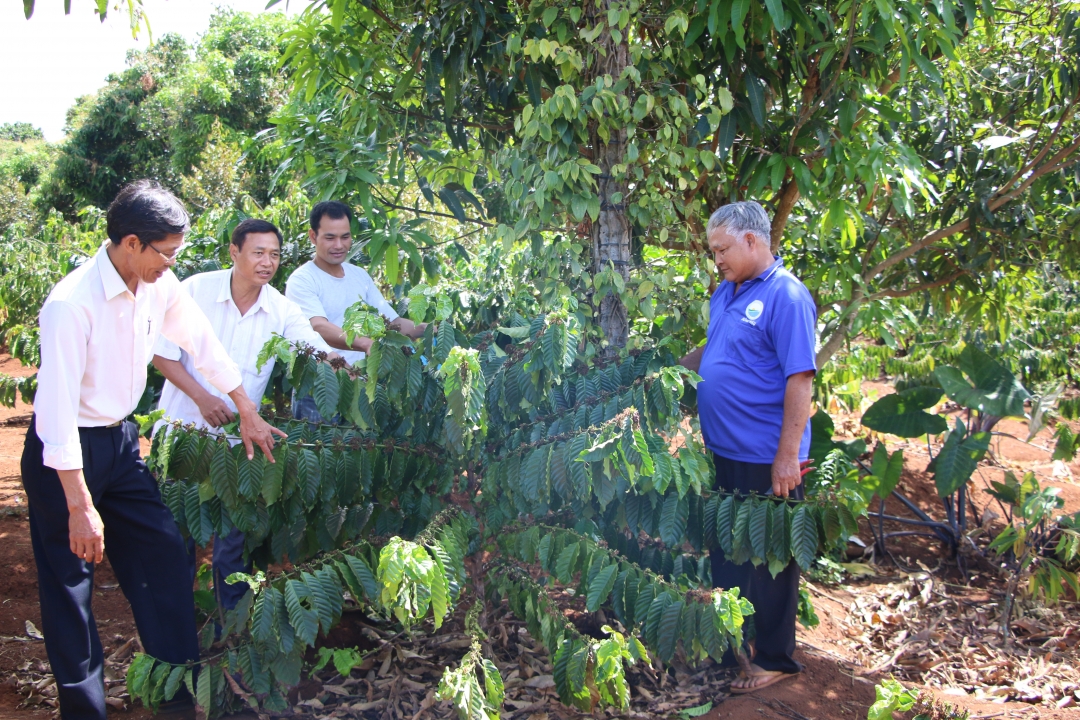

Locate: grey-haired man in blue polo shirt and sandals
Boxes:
[681,202,818,693]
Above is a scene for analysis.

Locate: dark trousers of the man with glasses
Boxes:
[23,420,199,720]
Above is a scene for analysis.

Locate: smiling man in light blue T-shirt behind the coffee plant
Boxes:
[285,200,428,422]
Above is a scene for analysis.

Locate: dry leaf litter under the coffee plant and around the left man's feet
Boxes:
[2,608,733,720]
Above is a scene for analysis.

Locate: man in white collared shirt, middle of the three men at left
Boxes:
[153,218,339,610]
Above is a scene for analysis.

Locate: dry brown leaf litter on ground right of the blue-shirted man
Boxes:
[814,572,1080,708]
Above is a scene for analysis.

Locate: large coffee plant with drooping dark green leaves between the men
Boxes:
[129,310,865,719]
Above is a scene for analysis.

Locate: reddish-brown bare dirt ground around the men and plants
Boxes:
[0,356,1080,720]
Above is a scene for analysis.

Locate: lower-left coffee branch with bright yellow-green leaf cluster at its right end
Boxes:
[129,512,470,715]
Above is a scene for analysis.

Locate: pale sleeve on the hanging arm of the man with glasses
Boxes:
[33,301,90,470]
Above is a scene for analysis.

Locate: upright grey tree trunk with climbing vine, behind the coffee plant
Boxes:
[585,0,630,357]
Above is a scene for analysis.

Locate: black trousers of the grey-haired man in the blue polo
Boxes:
[710,454,802,673]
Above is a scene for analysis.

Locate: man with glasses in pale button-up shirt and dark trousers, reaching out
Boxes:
[22,180,285,720]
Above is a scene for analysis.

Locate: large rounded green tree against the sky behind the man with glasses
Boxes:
[41,11,289,216]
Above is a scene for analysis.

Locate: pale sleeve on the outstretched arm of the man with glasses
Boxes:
[154,286,243,394]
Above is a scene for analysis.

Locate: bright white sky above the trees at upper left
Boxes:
[0,0,307,141]
